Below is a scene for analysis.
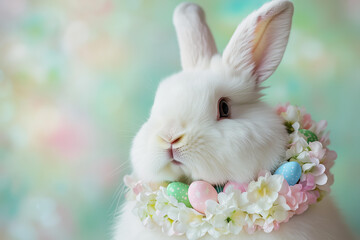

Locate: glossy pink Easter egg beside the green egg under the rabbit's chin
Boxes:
[188,181,217,213]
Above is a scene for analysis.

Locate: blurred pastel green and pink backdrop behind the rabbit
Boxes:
[0,0,360,240]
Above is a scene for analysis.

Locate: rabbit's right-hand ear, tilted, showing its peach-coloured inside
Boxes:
[223,0,294,83]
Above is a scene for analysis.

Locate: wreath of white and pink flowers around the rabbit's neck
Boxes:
[124,104,337,240]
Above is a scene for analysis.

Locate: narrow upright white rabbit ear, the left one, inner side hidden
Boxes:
[173,3,217,70]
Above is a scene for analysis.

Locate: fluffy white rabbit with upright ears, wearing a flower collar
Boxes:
[114,0,352,240]
